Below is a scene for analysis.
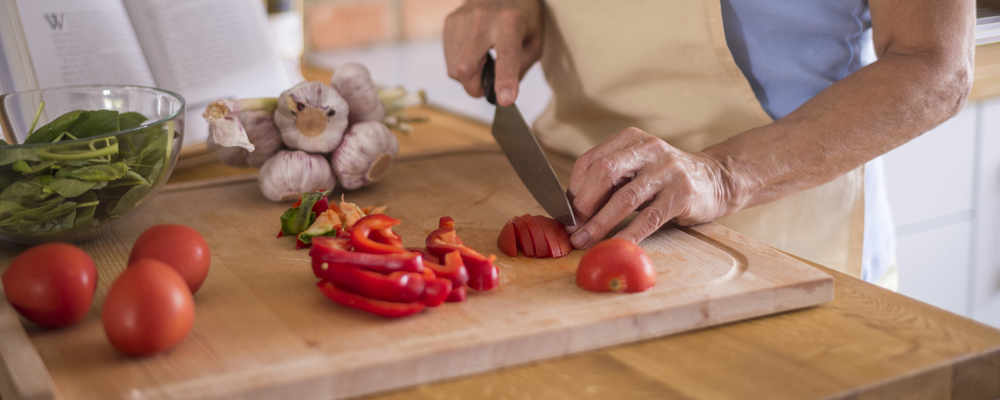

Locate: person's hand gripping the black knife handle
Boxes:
[444,0,542,106]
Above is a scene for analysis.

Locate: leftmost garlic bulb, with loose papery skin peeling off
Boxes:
[206,111,284,168]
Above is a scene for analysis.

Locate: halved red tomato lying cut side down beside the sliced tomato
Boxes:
[576,238,656,293]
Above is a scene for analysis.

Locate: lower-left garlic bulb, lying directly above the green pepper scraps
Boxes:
[257,150,337,201]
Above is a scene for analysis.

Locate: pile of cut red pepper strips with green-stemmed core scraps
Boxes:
[278,191,500,317]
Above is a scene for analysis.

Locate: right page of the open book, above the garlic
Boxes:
[125,0,291,106]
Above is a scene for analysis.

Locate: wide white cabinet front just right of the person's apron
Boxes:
[884,103,979,315]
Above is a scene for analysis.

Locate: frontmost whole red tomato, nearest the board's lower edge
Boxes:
[101,258,194,356]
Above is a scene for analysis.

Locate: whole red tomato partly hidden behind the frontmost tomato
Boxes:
[128,225,212,293]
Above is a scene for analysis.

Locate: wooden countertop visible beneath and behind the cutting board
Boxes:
[156,108,1000,399]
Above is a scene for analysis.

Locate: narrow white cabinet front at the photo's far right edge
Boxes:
[971,99,1000,327]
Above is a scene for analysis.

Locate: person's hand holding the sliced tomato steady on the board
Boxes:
[568,128,735,249]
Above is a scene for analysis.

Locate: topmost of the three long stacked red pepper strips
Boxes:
[309,236,424,274]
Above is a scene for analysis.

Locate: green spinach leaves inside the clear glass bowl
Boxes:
[0,103,175,236]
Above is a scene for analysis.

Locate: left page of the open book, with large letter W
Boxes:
[17,0,156,89]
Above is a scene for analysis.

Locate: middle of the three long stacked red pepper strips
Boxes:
[313,262,426,303]
